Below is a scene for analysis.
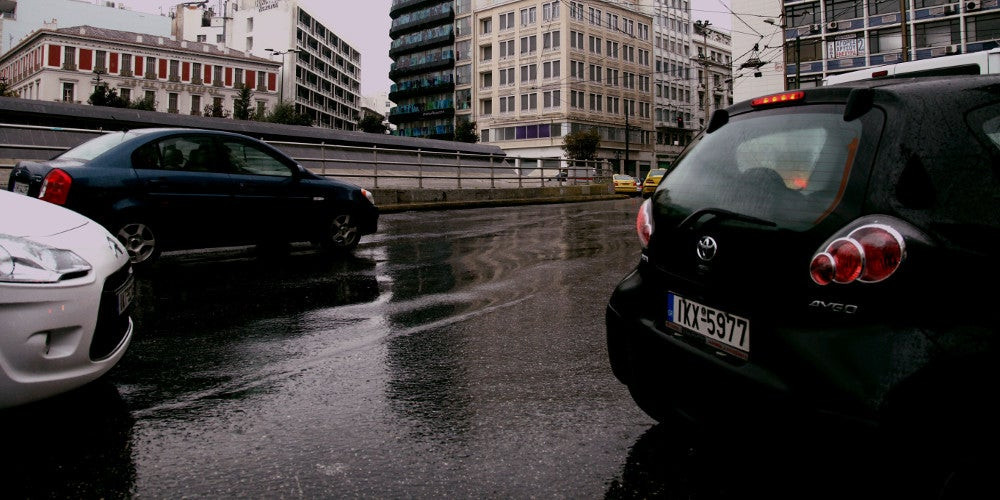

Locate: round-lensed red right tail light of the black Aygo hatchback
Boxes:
[809,224,906,285]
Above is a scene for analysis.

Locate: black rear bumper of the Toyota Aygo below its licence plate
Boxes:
[605,264,972,427]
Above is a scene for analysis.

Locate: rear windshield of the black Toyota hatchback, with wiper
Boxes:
[660,106,862,229]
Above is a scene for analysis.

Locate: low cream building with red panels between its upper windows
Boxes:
[0,26,279,116]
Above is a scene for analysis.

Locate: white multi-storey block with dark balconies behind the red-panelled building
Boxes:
[173,0,361,130]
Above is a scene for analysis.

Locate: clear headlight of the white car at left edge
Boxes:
[0,234,91,283]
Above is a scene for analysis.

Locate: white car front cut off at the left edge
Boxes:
[0,191,135,408]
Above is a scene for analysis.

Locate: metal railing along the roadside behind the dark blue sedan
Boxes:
[0,123,613,189]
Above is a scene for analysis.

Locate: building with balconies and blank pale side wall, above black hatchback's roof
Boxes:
[732,0,1000,100]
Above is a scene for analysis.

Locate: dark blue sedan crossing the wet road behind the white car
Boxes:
[8,129,378,265]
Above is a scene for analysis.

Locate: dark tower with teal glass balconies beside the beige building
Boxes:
[389,0,460,139]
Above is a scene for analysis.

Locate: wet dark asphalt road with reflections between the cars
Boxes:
[0,199,976,499]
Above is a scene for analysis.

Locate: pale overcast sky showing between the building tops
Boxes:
[122,0,732,96]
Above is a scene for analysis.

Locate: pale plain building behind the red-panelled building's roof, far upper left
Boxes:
[0,0,170,54]
